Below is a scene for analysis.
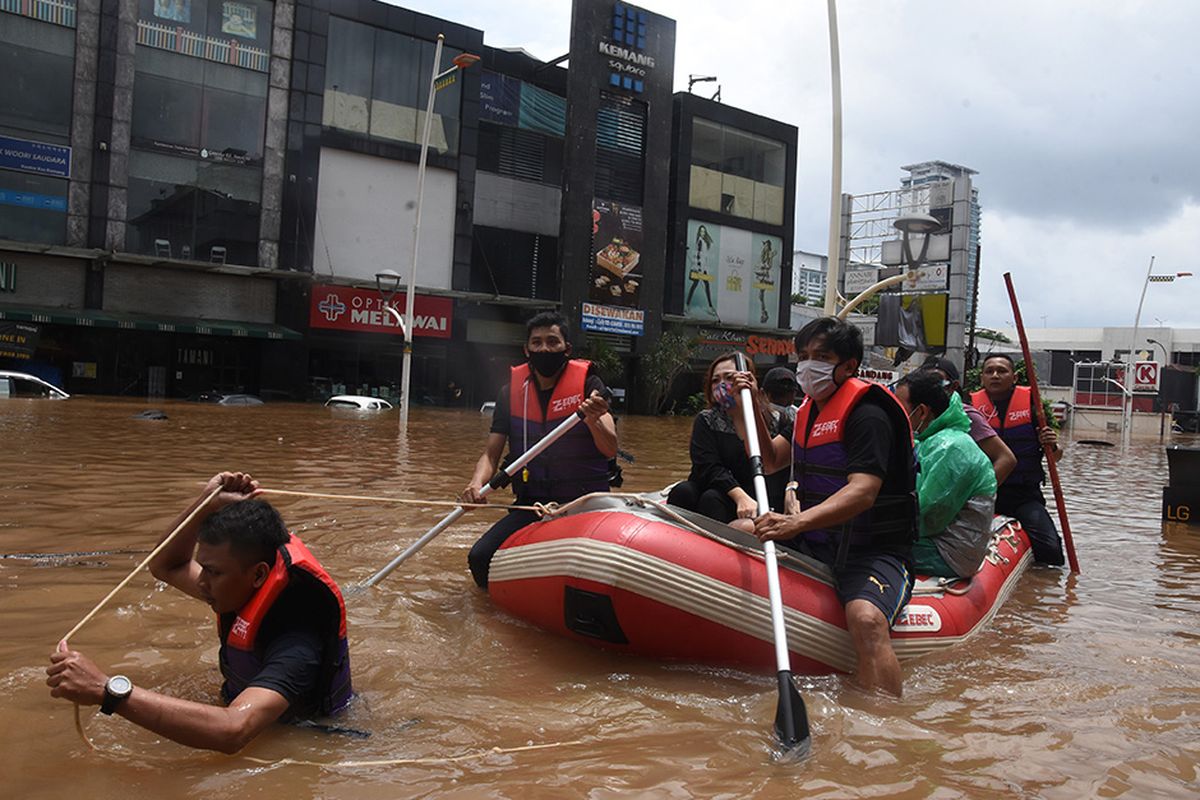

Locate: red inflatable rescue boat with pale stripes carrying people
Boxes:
[488,495,1033,675]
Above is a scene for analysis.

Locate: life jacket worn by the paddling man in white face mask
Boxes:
[785,378,917,564]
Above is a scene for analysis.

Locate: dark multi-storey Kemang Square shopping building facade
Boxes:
[0,0,796,402]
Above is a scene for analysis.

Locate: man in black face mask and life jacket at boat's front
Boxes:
[460,312,617,589]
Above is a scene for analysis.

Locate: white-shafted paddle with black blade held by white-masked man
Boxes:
[734,353,812,757]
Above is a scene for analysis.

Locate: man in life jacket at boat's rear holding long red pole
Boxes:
[971,354,1064,566]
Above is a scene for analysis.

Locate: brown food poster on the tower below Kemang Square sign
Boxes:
[588,200,642,308]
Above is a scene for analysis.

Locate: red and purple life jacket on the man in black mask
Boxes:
[509,359,608,503]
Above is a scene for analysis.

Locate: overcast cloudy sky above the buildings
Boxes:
[396,0,1200,327]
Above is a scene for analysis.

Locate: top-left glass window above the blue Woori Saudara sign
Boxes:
[0,14,74,144]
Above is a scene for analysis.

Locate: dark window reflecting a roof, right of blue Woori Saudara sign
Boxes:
[126,150,262,265]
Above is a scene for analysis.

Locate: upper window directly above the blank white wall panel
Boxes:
[323,17,462,154]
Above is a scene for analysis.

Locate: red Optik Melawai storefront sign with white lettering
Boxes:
[308,283,454,339]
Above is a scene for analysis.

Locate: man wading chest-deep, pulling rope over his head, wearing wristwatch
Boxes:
[46,473,352,753]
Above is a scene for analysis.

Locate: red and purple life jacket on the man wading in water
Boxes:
[217,534,353,715]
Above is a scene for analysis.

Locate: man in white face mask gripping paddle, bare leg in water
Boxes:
[736,317,917,696]
